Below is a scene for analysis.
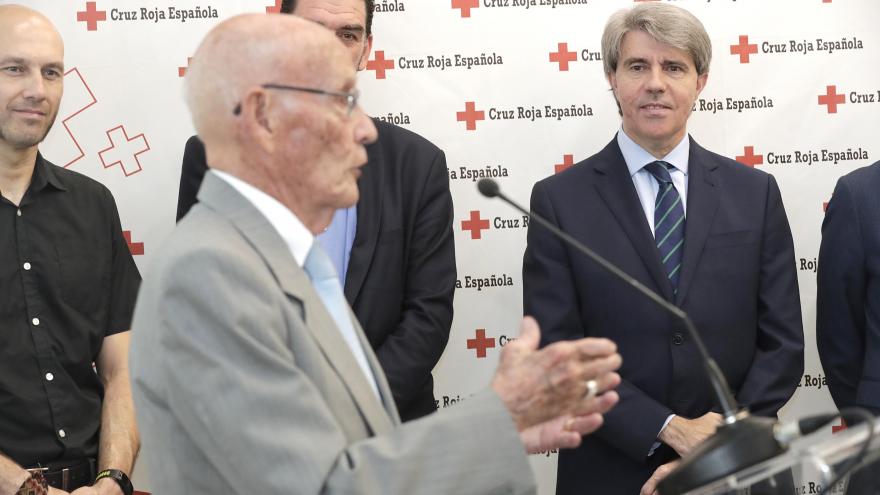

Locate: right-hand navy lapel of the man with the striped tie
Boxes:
[675,138,719,305]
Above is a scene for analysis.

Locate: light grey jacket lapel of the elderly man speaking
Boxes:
[198,171,393,432]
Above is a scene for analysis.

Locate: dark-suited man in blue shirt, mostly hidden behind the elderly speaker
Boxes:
[177,0,456,421]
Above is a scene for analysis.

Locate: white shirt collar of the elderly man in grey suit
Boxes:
[211,169,315,267]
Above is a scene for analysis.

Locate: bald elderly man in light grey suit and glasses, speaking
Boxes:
[132,15,620,495]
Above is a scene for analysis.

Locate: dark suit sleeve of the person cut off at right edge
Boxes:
[816,180,867,408]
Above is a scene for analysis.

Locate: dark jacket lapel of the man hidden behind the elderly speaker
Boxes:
[345,127,384,305]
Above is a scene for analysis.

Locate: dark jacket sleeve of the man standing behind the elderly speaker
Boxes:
[376,150,456,410]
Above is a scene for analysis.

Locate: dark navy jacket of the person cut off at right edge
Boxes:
[816,162,880,414]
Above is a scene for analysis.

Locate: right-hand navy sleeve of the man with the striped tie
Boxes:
[736,175,804,416]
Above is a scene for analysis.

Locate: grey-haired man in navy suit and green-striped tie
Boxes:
[523,3,803,495]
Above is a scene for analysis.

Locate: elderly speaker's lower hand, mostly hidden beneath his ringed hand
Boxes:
[519,391,619,454]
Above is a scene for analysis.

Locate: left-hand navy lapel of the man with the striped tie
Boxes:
[595,138,672,300]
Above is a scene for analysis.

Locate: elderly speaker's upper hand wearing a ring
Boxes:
[492,316,621,432]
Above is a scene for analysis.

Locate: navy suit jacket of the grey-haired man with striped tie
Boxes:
[523,139,803,495]
